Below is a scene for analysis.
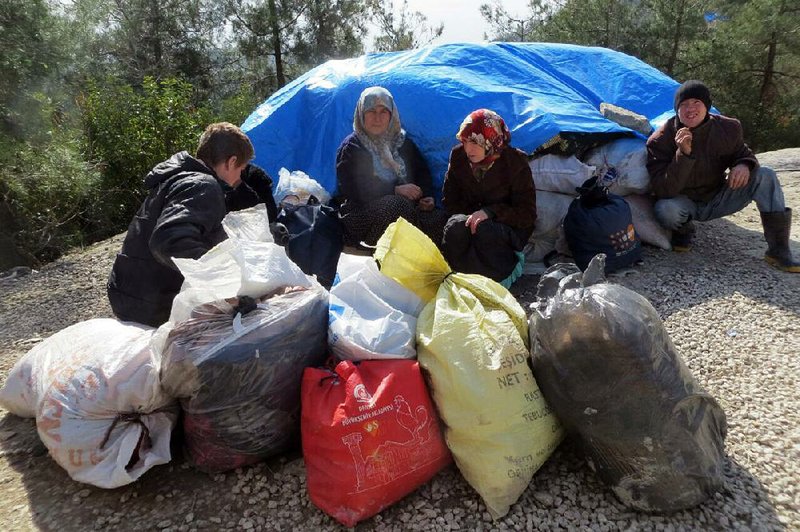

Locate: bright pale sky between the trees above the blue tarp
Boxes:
[406,0,528,44]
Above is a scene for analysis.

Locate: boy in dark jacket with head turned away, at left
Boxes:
[108,122,255,327]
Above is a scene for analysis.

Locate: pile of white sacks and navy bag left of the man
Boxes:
[525,137,672,273]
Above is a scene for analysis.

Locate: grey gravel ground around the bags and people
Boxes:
[0,149,800,531]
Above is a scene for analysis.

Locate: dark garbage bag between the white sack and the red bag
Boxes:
[161,287,328,471]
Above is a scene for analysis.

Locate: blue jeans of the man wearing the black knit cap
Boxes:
[655,166,786,231]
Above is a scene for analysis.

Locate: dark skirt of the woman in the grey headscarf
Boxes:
[341,195,447,247]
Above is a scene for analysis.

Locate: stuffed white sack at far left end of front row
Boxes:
[0,319,177,488]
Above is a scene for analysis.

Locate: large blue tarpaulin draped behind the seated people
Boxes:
[242,43,678,193]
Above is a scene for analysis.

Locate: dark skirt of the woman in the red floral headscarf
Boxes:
[442,214,529,282]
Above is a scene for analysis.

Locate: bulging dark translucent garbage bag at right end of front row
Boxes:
[530,255,727,512]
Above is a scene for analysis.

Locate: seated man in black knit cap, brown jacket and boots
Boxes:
[647,80,800,273]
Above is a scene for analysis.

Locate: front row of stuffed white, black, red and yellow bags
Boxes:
[0,207,725,526]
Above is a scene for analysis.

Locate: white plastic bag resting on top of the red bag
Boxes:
[328,260,422,360]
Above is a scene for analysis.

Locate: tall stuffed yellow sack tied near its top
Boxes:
[375,218,563,518]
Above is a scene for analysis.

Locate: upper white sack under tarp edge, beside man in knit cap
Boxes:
[584,138,650,196]
